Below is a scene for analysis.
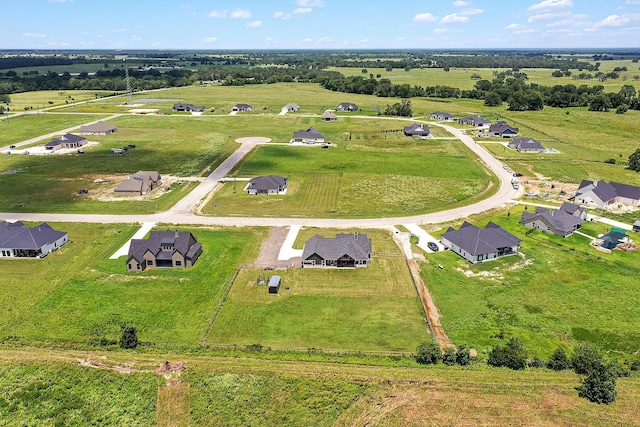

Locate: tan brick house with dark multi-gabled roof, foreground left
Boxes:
[127,230,202,271]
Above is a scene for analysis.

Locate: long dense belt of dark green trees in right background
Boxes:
[320,70,640,112]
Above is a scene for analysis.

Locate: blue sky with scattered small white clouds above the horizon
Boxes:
[0,0,640,49]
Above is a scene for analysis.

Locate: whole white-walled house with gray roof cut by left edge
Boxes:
[0,221,69,258]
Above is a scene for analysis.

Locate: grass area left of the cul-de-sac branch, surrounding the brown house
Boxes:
[0,115,238,214]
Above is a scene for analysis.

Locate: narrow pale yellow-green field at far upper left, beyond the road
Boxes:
[3,90,112,112]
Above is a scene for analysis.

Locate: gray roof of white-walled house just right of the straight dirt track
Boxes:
[442,221,521,256]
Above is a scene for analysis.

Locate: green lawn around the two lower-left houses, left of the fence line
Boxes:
[0,224,263,346]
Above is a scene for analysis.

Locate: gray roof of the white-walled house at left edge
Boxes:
[0,221,67,249]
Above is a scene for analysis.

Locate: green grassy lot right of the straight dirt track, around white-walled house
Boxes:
[422,207,640,358]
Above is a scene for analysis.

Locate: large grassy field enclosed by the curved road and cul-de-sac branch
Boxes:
[203,118,497,217]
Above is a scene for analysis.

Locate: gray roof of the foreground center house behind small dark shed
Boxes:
[302,233,371,261]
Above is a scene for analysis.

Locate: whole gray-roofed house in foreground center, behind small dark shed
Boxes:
[302,233,371,268]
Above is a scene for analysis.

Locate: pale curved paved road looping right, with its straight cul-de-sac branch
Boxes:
[0,116,517,228]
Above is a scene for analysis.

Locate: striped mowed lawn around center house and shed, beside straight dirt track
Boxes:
[207,229,430,352]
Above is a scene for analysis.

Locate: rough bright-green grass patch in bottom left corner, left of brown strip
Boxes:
[0,361,157,426]
